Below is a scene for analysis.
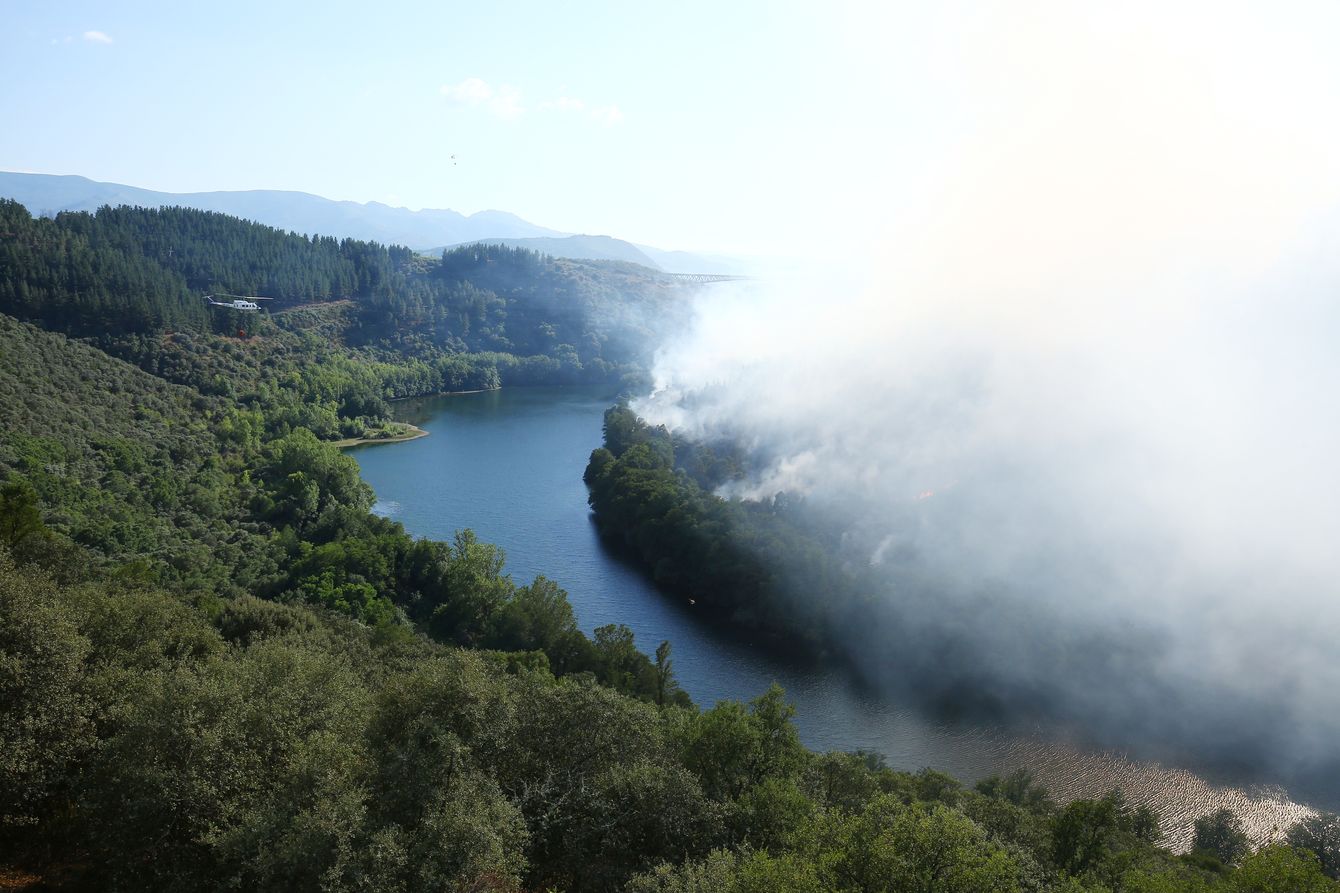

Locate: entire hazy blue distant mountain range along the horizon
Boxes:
[0,172,741,274]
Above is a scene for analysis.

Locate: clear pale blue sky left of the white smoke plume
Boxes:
[0,0,943,252]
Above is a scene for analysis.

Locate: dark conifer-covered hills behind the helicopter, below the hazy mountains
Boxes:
[0,200,683,383]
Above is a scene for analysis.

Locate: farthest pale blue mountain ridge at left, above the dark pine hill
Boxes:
[0,172,563,245]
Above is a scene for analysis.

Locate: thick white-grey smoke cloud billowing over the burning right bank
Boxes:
[635,5,1340,793]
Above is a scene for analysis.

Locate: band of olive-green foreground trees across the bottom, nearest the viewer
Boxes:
[0,548,1340,893]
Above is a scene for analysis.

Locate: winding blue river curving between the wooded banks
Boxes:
[348,388,1309,847]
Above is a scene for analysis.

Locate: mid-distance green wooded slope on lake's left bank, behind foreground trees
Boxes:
[0,316,683,700]
